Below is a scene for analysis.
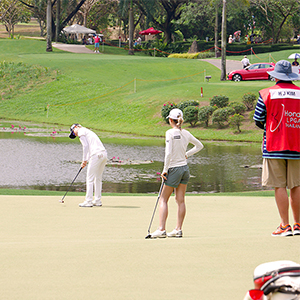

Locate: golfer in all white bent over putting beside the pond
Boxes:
[69,124,107,207]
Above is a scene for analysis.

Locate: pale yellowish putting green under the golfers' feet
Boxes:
[0,195,300,300]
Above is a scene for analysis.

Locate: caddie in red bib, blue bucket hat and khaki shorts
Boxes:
[253,60,300,236]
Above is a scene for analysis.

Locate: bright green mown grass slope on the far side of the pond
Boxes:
[0,39,300,142]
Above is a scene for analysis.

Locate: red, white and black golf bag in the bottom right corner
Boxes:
[244,260,300,300]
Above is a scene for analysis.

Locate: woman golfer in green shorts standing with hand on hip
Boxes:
[151,108,203,238]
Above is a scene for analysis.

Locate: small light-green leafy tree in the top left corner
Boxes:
[0,0,30,37]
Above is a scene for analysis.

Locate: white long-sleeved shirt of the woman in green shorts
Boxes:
[163,128,203,173]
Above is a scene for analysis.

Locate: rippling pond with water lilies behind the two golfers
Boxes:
[0,120,262,193]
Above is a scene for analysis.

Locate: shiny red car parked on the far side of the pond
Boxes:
[227,63,275,81]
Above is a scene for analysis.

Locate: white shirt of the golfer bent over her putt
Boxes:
[78,127,106,161]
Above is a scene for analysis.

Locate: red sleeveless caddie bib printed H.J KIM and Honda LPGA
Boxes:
[260,82,300,152]
